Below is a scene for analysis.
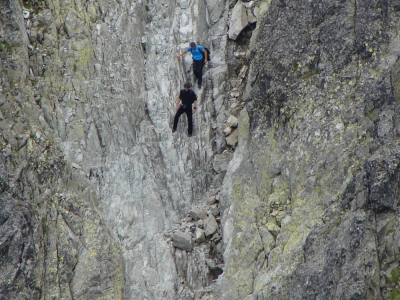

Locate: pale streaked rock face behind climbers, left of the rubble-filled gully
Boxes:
[0,0,230,299]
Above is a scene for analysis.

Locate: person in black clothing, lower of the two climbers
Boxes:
[172,83,197,136]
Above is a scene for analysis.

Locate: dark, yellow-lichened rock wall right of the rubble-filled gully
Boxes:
[219,0,400,299]
